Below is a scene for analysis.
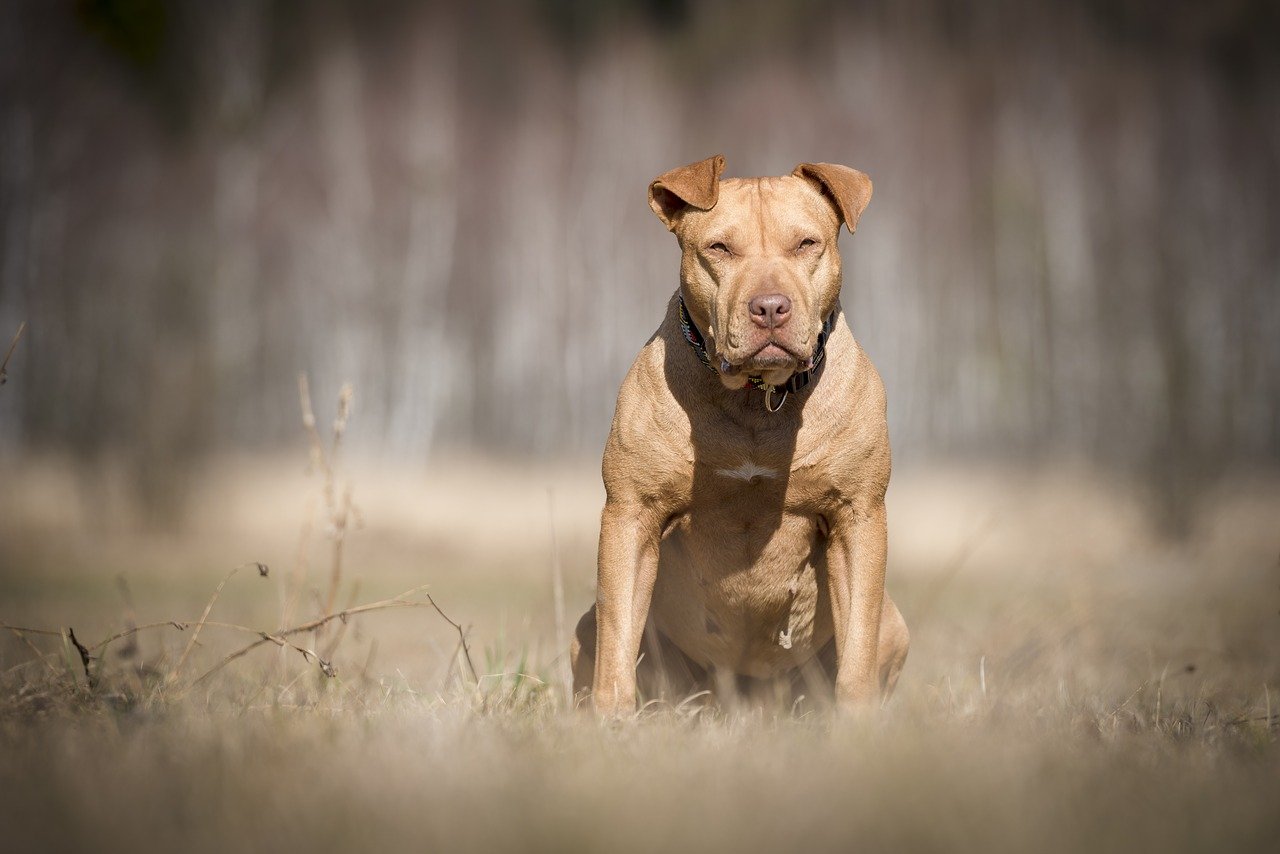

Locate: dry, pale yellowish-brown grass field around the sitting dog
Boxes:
[0,460,1280,851]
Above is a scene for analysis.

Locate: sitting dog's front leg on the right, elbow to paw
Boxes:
[827,499,888,709]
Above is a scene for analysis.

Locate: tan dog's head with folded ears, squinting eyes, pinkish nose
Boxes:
[649,155,872,388]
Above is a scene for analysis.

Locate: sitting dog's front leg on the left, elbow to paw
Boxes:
[591,498,662,717]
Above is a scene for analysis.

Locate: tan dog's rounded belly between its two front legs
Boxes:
[650,481,832,677]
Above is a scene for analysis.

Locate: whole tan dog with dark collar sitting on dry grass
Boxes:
[571,156,908,716]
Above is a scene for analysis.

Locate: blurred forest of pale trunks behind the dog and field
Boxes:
[0,0,1280,530]
